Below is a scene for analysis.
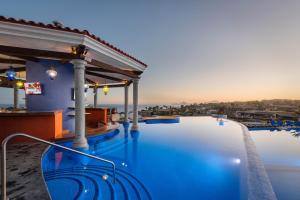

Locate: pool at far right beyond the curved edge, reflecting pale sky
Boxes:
[250,129,300,200]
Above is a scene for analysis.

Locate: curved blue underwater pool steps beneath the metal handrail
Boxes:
[44,165,152,200]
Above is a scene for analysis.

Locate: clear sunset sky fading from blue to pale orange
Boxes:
[0,0,300,104]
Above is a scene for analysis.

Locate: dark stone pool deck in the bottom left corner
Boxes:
[0,143,50,200]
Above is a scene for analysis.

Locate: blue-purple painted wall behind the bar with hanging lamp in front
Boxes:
[26,60,75,132]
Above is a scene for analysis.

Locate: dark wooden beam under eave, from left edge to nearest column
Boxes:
[0,45,83,60]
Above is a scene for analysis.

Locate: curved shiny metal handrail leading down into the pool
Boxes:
[1,133,116,200]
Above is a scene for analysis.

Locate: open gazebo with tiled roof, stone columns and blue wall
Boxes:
[0,16,147,148]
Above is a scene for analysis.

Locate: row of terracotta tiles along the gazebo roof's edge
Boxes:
[0,15,147,67]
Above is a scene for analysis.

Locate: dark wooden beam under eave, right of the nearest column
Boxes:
[88,59,138,78]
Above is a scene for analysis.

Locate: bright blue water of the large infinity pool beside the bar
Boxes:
[42,117,247,200]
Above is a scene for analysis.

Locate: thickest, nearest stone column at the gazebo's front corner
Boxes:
[71,59,88,148]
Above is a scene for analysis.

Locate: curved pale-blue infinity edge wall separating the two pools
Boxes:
[237,122,277,200]
